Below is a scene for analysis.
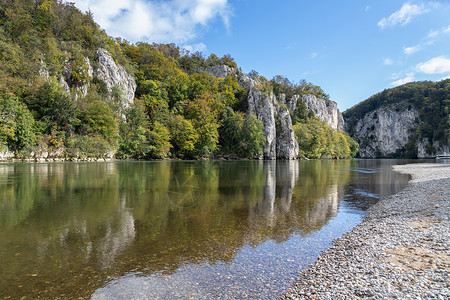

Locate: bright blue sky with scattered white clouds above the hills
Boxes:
[73,0,450,111]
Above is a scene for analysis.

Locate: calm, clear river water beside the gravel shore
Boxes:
[0,160,414,299]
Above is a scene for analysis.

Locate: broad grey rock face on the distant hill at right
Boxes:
[350,105,419,158]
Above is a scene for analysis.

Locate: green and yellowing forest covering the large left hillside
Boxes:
[0,0,357,159]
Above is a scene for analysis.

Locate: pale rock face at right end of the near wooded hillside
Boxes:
[301,95,344,131]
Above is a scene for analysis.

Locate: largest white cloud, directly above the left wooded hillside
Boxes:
[73,0,231,43]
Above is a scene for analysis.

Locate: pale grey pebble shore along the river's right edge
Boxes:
[283,164,450,299]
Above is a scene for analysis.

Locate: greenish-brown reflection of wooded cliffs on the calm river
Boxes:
[0,161,408,298]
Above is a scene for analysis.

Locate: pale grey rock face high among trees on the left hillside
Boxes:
[94,49,136,102]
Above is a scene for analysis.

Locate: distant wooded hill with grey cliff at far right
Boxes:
[343,79,450,158]
